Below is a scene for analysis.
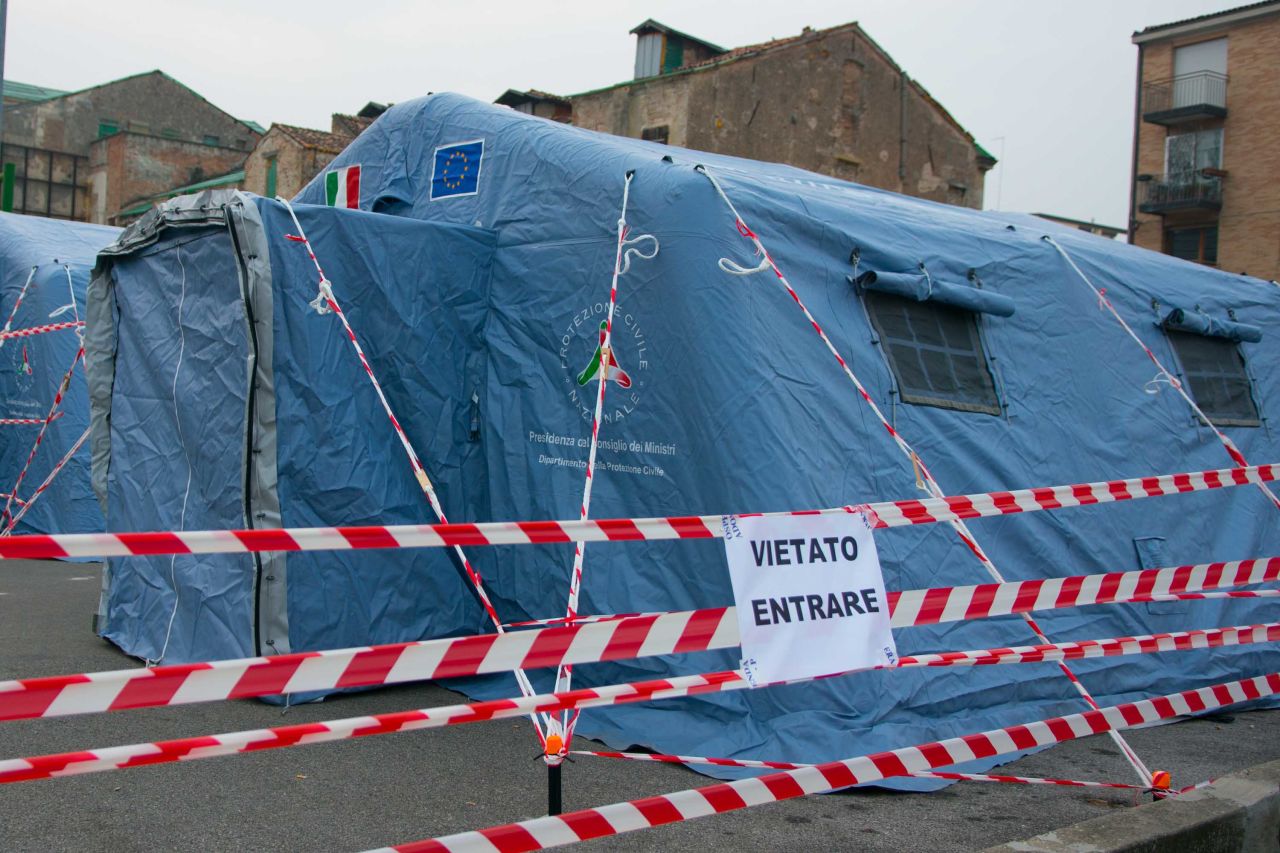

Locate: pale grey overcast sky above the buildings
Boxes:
[4,0,1244,225]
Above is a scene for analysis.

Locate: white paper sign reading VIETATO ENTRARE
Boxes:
[721,512,897,685]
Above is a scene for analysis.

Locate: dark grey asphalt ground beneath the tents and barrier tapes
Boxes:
[0,561,1280,853]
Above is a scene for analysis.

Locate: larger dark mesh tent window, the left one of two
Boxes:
[864,291,1000,415]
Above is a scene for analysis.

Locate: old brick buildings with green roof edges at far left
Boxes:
[0,70,261,224]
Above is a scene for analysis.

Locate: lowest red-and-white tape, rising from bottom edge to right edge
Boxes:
[371,674,1280,853]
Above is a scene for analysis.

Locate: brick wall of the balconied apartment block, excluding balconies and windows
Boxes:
[1132,15,1280,279]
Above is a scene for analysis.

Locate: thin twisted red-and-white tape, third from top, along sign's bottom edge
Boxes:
[0,624,1280,784]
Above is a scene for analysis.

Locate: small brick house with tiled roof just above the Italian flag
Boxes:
[244,102,387,199]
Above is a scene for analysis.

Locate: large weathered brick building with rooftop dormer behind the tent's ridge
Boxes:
[498,20,996,207]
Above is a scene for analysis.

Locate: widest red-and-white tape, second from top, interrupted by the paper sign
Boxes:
[0,557,1280,720]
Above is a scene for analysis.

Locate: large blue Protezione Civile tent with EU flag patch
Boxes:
[90,95,1280,772]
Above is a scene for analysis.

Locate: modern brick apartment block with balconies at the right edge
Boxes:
[1129,0,1280,279]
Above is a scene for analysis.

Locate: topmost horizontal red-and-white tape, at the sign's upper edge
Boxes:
[0,465,1264,560]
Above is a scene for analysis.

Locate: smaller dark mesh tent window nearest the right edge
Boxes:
[1166,329,1261,427]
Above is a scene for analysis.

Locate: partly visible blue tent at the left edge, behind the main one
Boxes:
[0,214,120,533]
